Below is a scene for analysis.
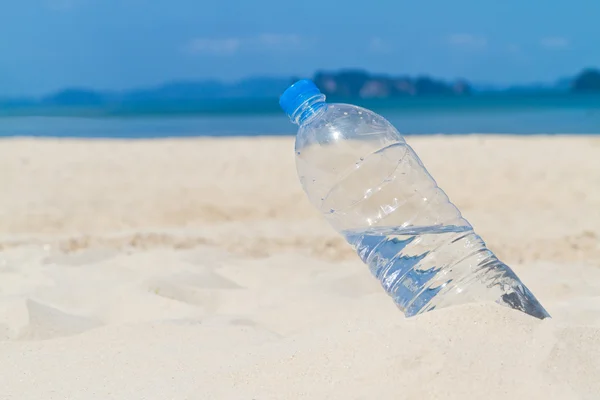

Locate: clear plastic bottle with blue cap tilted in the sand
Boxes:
[279,80,549,318]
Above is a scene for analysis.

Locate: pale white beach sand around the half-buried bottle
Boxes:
[0,136,600,400]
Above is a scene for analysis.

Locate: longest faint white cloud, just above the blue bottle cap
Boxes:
[185,33,305,56]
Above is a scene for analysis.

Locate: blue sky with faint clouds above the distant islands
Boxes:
[0,0,600,97]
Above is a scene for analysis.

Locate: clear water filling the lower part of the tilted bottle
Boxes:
[344,226,549,318]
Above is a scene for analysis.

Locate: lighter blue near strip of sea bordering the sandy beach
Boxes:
[0,104,600,139]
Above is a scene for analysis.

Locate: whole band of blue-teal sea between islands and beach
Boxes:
[0,94,600,139]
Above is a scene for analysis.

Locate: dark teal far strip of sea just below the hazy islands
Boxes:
[0,92,600,118]
